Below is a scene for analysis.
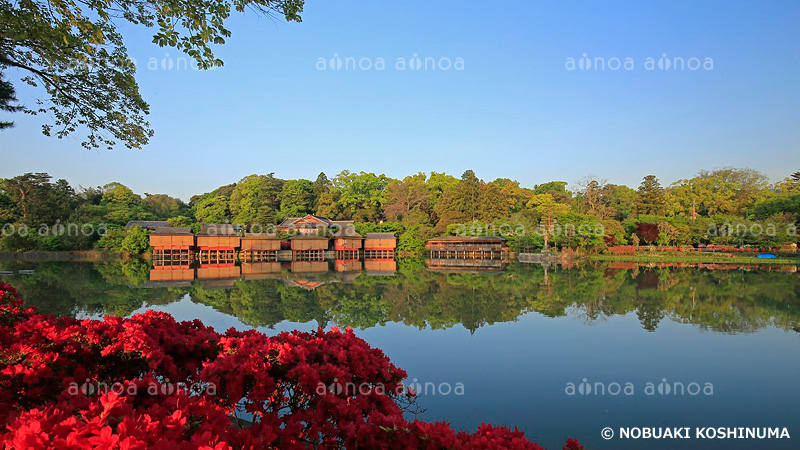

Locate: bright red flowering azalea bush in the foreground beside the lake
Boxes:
[0,283,584,450]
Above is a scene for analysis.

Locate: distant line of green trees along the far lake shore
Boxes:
[0,168,800,253]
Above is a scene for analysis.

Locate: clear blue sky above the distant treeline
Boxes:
[0,0,800,200]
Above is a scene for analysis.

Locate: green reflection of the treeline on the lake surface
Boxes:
[6,260,800,333]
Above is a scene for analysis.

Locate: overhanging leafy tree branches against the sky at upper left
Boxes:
[0,0,303,149]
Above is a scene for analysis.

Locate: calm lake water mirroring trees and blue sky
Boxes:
[0,260,800,449]
